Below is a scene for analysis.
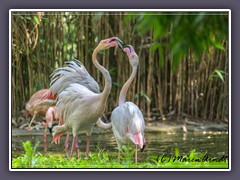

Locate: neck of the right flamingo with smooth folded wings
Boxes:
[118,66,137,105]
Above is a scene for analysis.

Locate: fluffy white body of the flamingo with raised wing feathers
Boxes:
[54,83,104,136]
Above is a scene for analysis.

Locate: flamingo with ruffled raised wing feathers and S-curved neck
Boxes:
[50,37,122,157]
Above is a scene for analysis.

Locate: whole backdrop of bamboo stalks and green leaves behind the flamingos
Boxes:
[11,12,229,122]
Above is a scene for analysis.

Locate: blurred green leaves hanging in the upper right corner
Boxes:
[125,12,228,71]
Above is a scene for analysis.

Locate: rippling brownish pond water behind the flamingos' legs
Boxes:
[12,128,229,161]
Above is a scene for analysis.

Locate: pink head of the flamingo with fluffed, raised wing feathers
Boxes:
[97,37,124,50]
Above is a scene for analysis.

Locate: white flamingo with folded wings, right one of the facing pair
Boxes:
[111,45,146,163]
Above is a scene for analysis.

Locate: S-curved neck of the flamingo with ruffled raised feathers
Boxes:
[92,48,112,102]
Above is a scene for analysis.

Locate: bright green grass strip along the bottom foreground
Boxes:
[12,141,228,169]
